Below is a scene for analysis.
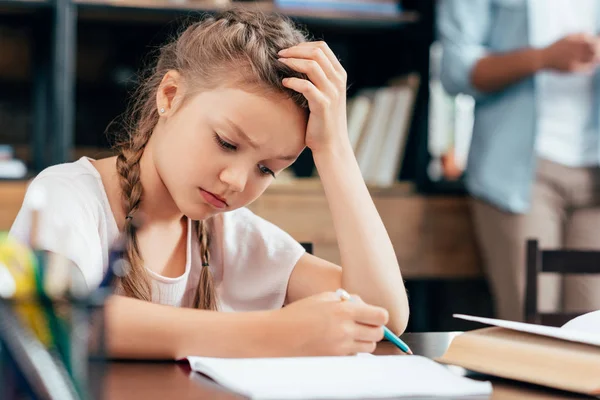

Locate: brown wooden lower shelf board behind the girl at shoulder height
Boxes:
[0,179,481,279]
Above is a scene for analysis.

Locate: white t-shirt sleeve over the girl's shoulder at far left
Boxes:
[10,159,118,287]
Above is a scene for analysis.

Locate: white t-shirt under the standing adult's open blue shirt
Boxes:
[532,0,599,167]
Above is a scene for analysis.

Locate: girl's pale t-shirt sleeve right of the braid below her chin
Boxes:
[221,208,305,310]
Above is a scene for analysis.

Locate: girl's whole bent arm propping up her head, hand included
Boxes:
[280,42,409,333]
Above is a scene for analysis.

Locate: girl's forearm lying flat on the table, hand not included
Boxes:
[105,295,281,360]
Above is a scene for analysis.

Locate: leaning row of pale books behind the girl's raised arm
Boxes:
[347,74,420,187]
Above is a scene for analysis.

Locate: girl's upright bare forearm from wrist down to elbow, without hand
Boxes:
[313,142,409,334]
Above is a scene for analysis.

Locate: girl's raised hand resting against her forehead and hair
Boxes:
[279,42,348,153]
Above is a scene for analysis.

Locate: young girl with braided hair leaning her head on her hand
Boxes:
[11,10,408,358]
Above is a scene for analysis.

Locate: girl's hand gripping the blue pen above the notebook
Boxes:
[272,292,388,356]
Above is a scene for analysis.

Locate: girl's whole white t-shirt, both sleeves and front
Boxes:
[10,157,305,311]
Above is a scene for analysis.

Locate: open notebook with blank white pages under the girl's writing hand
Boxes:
[187,356,492,400]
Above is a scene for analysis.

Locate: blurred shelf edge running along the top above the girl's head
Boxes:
[74,0,419,28]
